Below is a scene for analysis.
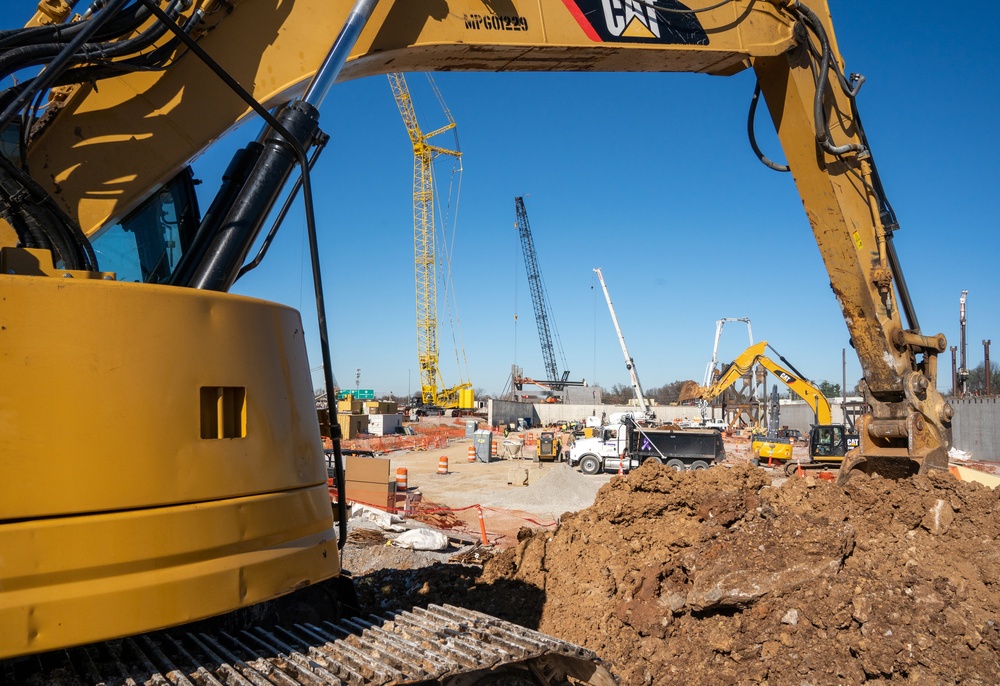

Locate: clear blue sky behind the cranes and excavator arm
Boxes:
[7,0,1000,394]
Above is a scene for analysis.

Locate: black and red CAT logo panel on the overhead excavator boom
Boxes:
[563,0,708,45]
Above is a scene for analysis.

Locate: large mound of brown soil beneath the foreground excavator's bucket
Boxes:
[352,465,1000,684]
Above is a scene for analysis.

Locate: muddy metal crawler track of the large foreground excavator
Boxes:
[0,605,616,686]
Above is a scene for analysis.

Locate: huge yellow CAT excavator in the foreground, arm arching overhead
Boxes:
[0,0,952,686]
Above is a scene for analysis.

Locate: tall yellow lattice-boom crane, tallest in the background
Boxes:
[387,73,473,409]
